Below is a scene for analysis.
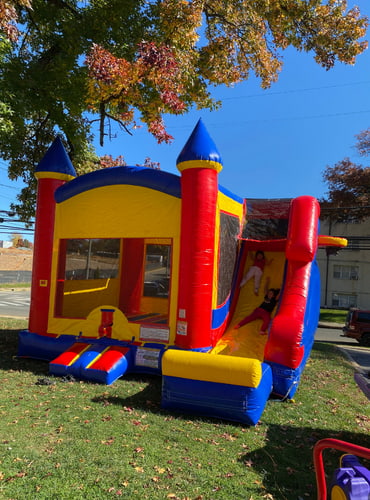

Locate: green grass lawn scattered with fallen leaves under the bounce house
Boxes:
[0,319,370,500]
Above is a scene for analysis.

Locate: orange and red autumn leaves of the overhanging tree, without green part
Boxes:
[87,0,367,143]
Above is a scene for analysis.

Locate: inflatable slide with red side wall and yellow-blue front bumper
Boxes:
[163,197,326,424]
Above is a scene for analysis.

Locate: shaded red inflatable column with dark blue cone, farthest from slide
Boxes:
[28,138,76,334]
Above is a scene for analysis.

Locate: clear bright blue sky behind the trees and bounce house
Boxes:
[0,0,370,239]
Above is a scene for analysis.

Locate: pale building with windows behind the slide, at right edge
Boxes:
[317,218,370,309]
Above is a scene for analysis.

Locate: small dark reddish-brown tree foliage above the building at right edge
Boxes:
[321,128,370,222]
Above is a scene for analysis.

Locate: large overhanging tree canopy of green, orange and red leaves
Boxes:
[0,0,367,217]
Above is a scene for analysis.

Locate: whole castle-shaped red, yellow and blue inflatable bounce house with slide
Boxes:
[18,120,345,425]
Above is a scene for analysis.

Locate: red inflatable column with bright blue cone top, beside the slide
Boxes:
[175,121,222,349]
